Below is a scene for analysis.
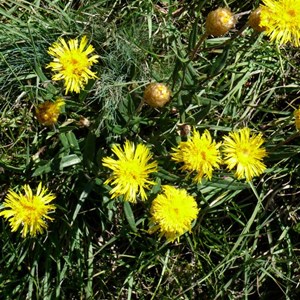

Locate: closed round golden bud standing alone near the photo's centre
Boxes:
[144,83,171,107]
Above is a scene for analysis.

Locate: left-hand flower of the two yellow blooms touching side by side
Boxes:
[171,129,221,182]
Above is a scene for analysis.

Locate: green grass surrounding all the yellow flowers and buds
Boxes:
[0,0,300,300]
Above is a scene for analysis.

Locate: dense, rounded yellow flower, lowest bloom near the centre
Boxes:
[149,185,200,242]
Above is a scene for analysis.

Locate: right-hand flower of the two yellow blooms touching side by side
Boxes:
[223,127,267,181]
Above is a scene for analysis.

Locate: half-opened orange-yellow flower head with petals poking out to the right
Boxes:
[35,98,65,126]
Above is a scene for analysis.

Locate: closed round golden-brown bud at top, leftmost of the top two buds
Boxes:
[205,7,236,36]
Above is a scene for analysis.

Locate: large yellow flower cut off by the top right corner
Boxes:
[260,0,300,47]
